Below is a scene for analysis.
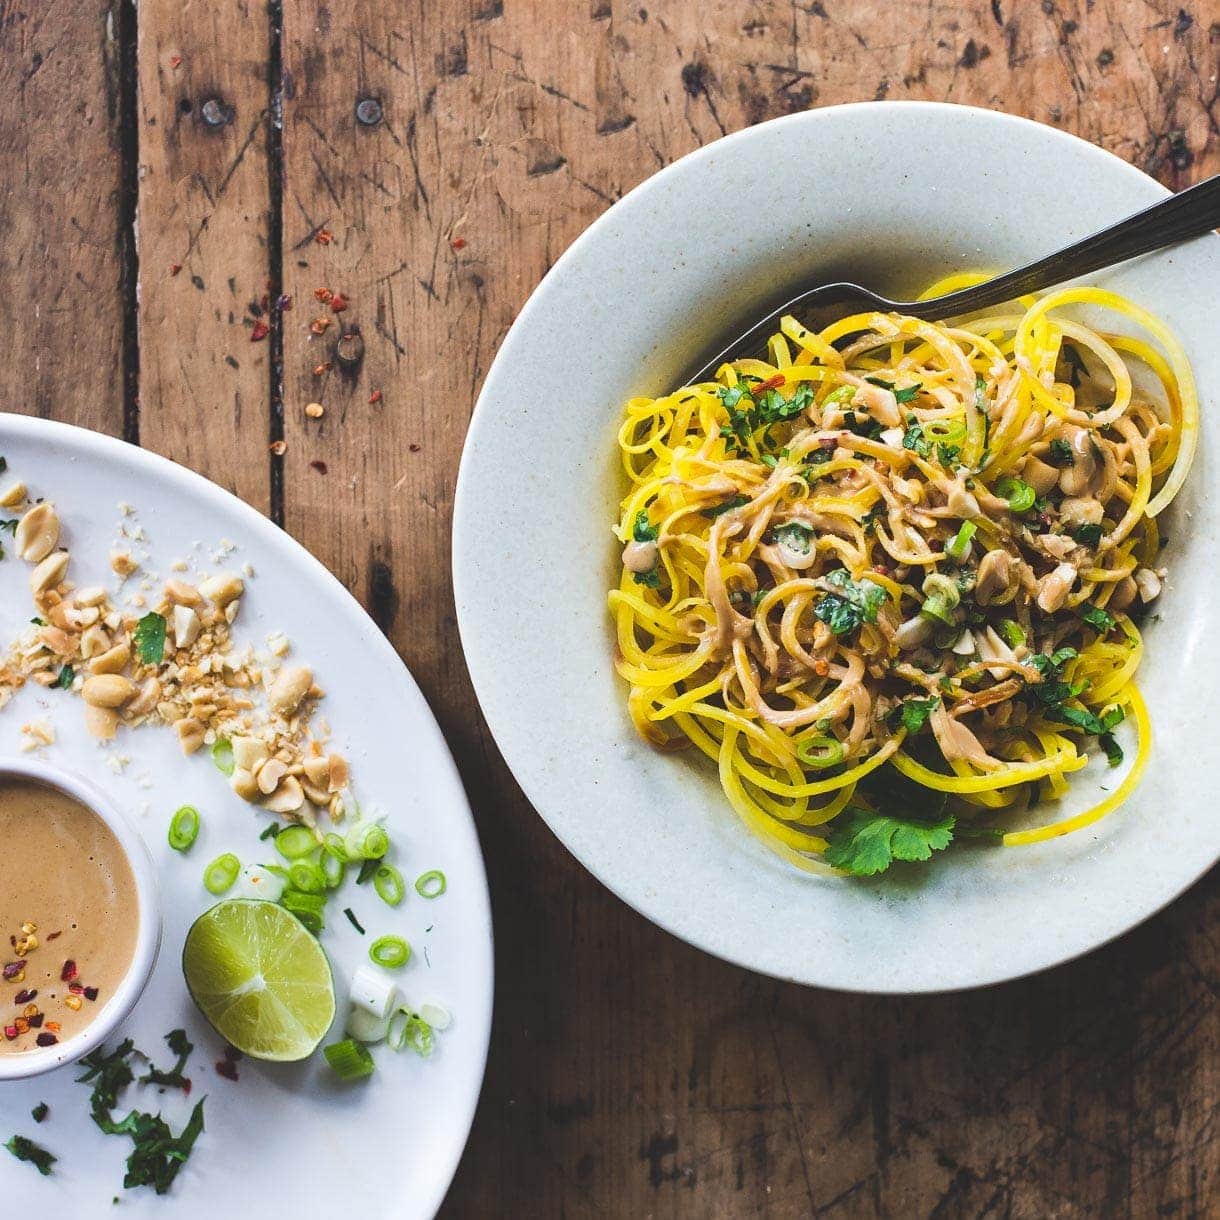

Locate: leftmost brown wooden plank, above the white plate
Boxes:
[0,0,131,434]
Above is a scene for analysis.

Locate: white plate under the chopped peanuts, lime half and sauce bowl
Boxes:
[0,415,492,1220]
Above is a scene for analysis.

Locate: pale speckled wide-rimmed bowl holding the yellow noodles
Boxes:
[454,102,1220,992]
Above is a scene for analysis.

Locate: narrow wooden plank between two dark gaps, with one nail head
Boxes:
[139,0,273,510]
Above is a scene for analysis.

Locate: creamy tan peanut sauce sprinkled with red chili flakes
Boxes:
[0,778,139,1054]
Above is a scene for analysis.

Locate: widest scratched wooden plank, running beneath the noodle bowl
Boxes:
[272,0,1220,1218]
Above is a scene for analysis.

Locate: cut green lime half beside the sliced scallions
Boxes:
[182,898,334,1061]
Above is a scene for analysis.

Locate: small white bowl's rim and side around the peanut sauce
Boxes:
[0,759,161,1081]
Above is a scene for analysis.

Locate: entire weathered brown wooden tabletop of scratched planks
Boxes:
[0,0,1220,1218]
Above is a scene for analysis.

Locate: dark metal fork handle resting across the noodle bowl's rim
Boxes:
[906,174,1220,318]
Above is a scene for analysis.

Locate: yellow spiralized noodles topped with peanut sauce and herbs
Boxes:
[610,280,1198,874]
